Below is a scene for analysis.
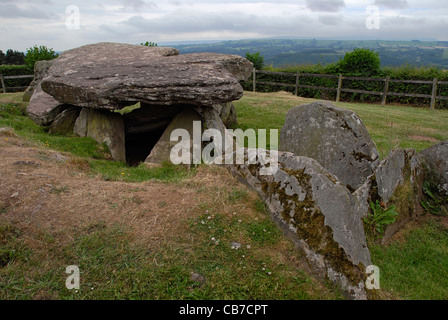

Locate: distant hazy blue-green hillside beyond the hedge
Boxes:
[172,39,448,69]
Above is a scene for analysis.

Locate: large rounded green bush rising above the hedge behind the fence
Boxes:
[337,48,381,76]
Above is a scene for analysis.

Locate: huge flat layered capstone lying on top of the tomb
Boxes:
[41,43,252,109]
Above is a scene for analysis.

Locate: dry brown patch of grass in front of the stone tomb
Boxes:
[0,138,201,248]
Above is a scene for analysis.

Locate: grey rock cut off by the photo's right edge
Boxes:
[419,140,448,196]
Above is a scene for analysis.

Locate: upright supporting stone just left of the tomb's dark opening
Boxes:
[74,108,126,162]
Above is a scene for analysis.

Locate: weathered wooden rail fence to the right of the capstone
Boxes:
[248,68,448,109]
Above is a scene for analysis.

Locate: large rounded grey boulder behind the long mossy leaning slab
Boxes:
[279,101,379,191]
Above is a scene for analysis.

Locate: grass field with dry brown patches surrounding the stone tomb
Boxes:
[0,92,448,300]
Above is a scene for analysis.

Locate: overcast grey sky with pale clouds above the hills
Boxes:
[0,0,448,51]
